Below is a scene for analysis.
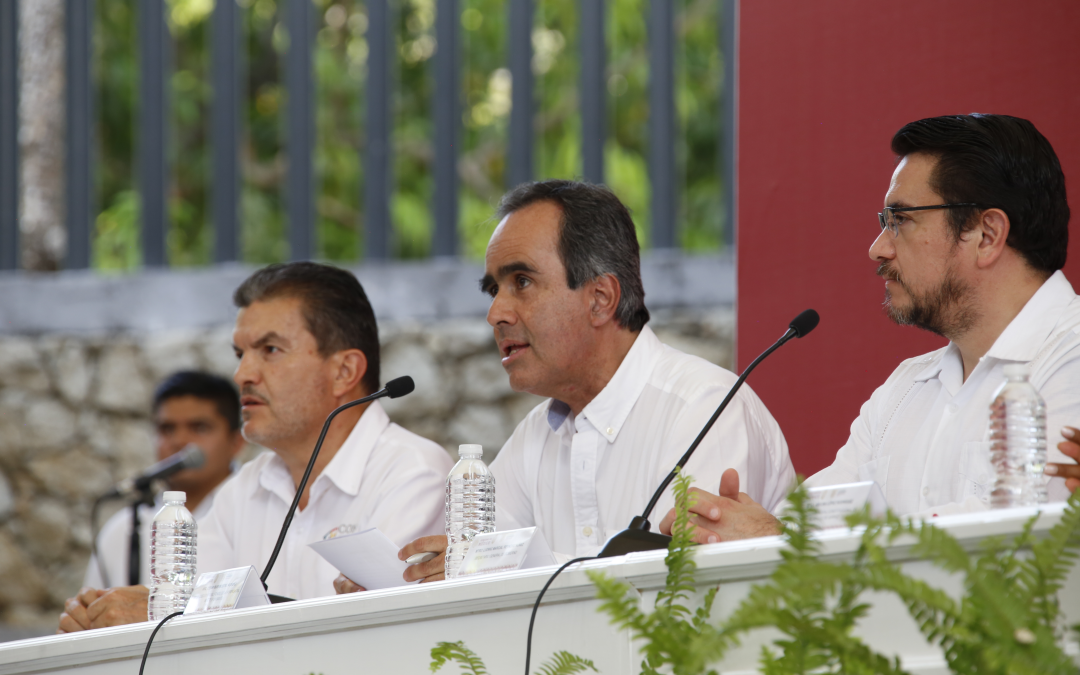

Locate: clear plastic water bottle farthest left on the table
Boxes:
[147,491,198,621]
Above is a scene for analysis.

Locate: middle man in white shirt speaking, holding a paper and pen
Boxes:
[399,180,795,580]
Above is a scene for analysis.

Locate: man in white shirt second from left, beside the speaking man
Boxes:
[61,262,453,623]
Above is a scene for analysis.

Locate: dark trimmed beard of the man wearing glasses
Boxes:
[877,261,978,340]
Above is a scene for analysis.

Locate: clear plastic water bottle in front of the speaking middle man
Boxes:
[446,444,495,579]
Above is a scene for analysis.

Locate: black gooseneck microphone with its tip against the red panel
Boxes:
[596,309,821,557]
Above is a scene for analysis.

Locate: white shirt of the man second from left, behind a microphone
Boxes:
[199,401,453,599]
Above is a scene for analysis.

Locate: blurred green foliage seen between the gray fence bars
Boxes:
[86,0,725,270]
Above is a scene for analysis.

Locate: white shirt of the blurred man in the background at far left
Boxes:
[82,476,231,589]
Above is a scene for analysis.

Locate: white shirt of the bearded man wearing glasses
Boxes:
[807,271,1080,516]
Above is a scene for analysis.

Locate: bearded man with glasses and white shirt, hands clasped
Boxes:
[660,114,1080,543]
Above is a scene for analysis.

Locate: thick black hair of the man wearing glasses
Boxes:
[892,113,1069,275]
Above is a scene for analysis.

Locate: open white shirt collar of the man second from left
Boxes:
[259,401,390,502]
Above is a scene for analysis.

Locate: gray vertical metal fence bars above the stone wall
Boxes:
[0,0,738,269]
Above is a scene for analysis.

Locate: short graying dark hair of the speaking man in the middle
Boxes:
[498,180,649,333]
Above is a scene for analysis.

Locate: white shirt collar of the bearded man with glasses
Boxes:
[915,270,1076,381]
